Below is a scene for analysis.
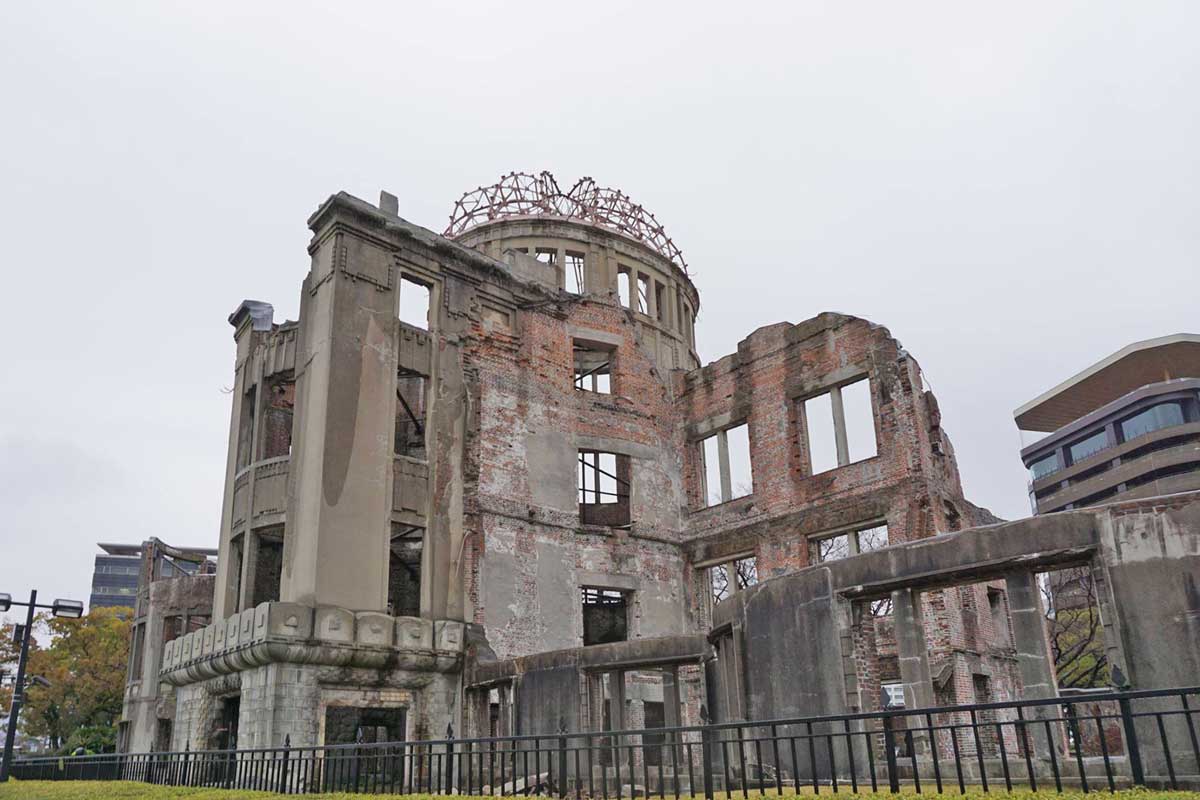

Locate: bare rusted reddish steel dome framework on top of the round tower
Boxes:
[443,172,688,273]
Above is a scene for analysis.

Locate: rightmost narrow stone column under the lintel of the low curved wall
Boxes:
[1004,572,1058,756]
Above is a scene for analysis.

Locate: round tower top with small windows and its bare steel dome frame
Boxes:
[443,172,700,371]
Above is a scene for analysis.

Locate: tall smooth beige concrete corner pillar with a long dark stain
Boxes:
[281,209,397,612]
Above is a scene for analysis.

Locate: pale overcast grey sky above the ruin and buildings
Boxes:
[0,0,1200,600]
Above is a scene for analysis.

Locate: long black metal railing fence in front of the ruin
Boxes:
[13,687,1200,800]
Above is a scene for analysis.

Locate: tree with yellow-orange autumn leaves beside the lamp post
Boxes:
[22,608,132,750]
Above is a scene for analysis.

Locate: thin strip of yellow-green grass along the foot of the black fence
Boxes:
[0,781,1200,800]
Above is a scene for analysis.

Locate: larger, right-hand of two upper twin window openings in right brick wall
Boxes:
[804,378,878,475]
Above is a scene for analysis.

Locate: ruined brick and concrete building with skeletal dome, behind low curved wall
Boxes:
[147,173,1190,750]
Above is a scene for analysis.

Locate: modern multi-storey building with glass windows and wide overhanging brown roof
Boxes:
[1014,333,1200,513]
